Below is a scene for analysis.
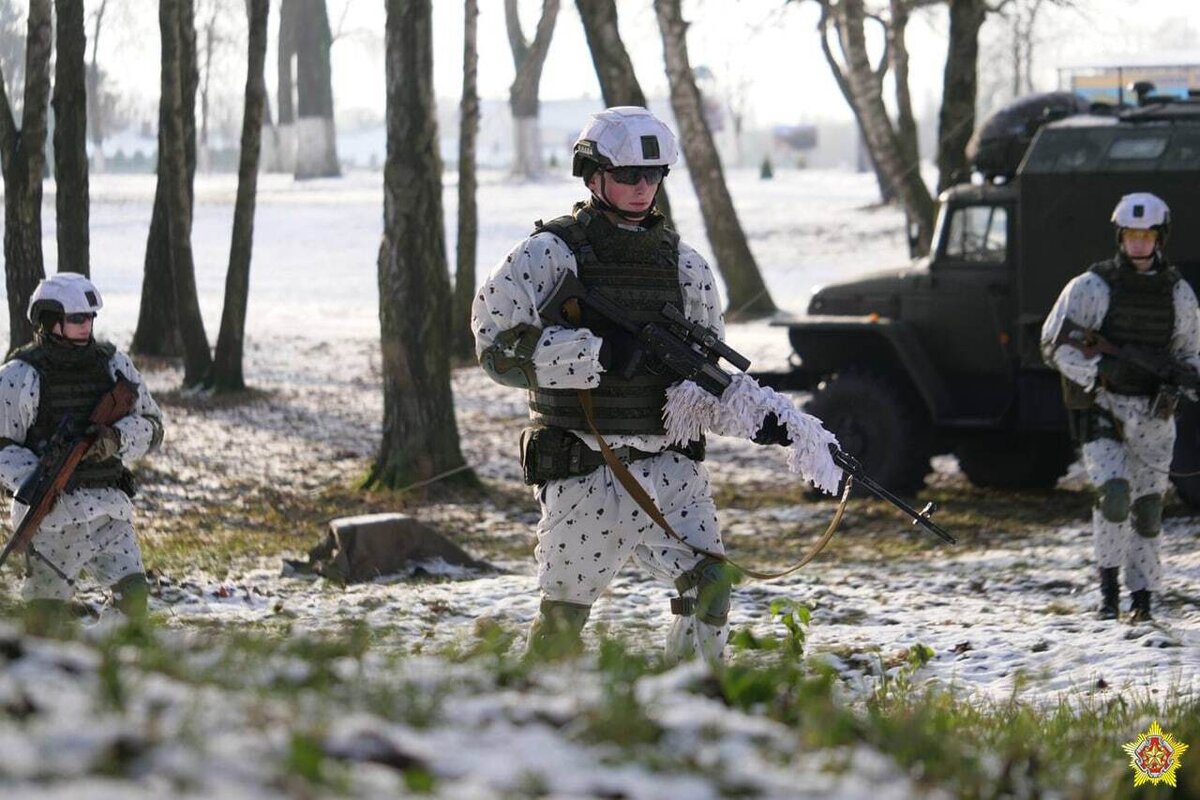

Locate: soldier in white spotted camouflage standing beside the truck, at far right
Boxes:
[1042,193,1200,621]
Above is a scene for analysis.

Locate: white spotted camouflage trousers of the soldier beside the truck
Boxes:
[1082,415,1175,591]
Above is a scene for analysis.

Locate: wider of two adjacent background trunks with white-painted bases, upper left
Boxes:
[295,0,342,179]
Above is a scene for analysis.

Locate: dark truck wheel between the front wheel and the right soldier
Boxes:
[954,433,1076,489]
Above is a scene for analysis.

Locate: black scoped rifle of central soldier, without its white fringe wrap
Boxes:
[538,270,956,545]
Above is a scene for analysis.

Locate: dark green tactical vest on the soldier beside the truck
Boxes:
[1092,257,1182,395]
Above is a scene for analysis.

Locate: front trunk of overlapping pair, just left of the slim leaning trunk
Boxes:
[158,0,212,386]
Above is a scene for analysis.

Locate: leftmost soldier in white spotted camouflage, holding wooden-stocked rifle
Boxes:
[0,272,163,625]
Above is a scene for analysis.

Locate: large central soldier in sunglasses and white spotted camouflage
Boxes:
[472,107,840,660]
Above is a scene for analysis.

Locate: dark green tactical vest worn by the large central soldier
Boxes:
[529,203,683,434]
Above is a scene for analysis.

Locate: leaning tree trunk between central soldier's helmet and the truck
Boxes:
[654,0,775,319]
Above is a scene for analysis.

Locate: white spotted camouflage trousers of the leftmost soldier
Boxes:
[22,517,145,600]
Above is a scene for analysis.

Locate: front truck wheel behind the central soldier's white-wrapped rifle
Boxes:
[804,371,932,493]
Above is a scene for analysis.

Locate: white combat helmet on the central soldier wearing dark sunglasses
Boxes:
[571,106,679,178]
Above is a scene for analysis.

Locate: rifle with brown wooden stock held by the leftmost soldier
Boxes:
[0,373,138,566]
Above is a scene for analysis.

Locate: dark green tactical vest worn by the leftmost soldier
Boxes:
[11,339,128,491]
